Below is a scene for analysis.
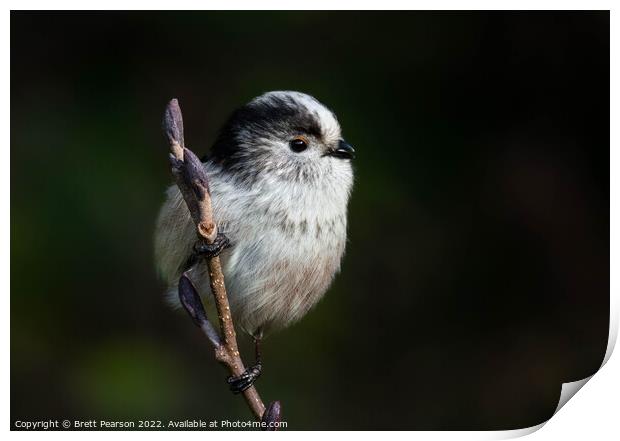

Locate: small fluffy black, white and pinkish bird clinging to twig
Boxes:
[155,91,355,392]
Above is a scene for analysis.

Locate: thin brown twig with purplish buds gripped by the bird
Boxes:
[164,99,280,422]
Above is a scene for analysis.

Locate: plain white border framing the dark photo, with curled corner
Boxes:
[0,0,620,441]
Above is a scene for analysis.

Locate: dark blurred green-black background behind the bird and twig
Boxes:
[11,12,609,430]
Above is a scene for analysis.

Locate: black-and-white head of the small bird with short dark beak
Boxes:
[211,91,355,184]
